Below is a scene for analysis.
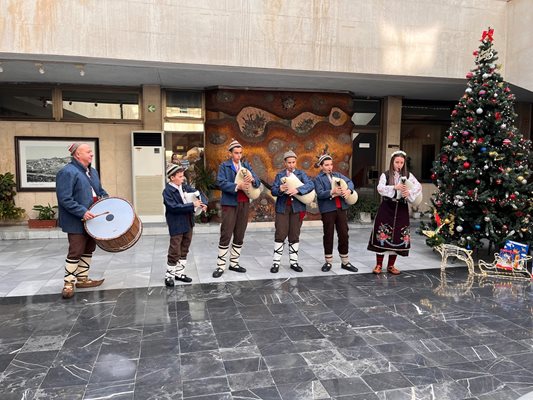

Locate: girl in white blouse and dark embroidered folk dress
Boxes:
[368,150,422,275]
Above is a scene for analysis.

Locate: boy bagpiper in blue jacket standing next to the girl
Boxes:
[314,154,358,272]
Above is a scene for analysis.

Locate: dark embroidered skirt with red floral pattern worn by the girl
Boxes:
[367,197,411,256]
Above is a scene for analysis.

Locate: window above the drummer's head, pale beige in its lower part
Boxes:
[62,90,139,120]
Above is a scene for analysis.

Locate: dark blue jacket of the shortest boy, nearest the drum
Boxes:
[163,183,207,236]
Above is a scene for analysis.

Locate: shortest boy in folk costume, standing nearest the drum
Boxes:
[163,165,207,286]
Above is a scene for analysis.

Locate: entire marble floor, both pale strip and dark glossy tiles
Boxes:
[0,229,533,400]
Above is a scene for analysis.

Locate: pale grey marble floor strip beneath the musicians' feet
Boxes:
[0,225,440,297]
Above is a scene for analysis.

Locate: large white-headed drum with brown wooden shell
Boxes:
[84,197,142,253]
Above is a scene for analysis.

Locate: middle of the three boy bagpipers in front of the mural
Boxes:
[270,150,314,274]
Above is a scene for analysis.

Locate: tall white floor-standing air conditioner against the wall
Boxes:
[131,131,165,222]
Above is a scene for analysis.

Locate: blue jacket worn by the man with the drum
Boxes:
[56,158,108,233]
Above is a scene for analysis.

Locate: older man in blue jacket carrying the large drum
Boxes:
[56,143,108,299]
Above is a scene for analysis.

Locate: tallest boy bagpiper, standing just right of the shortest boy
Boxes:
[213,140,261,278]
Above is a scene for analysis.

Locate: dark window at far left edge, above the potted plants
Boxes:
[0,87,53,119]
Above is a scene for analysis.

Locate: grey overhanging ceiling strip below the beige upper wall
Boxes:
[0,53,533,102]
